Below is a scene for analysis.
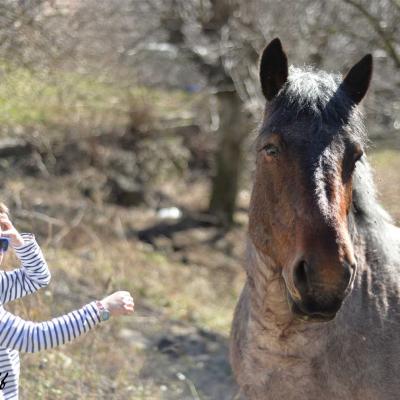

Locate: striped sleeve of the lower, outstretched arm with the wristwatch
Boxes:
[0,301,101,353]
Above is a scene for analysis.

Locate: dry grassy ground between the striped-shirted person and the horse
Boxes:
[5,178,246,400]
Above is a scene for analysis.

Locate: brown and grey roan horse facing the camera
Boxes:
[230,38,400,400]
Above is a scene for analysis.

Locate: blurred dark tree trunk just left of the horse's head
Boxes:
[209,90,247,227]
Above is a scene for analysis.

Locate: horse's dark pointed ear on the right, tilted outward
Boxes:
[342,54,372,104]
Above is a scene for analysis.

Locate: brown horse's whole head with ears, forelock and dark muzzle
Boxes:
[249,39,372,320]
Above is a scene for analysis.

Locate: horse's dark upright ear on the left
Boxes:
[260,38,288,100]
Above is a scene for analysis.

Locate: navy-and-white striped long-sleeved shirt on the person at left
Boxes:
[0,233,100,400]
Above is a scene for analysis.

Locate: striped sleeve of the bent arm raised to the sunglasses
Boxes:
[0,233,51,304]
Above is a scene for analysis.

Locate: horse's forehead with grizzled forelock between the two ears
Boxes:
[264,67,355,148]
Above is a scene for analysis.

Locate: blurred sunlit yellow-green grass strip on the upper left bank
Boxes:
[0,60,193,130]
